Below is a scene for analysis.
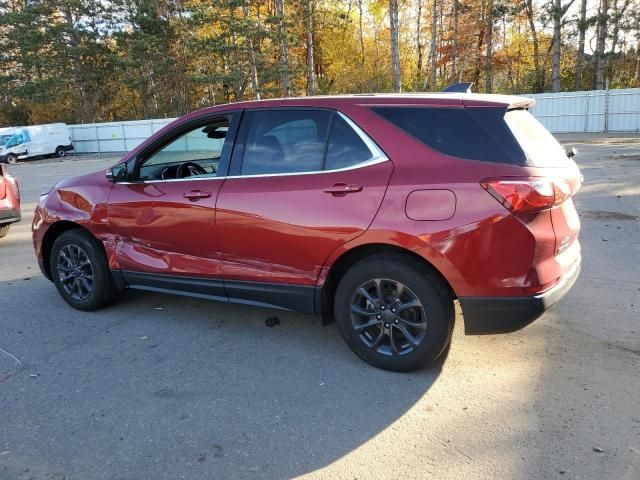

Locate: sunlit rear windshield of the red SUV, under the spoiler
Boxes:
[504,110,570,167]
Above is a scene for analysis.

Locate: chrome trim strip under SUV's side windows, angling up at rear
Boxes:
[116,112,389,185]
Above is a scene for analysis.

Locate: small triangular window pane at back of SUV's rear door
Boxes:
[325,115,373,170]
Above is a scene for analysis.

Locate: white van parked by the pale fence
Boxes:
[0,123,73,163]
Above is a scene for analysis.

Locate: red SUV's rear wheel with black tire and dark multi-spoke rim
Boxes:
[334,254,455,372]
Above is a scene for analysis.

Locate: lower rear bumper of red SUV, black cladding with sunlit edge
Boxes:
[458,258,580,335]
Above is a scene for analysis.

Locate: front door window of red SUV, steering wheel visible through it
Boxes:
[138,117,231,180]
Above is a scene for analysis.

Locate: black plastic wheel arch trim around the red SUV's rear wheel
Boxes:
[315,243,456,325]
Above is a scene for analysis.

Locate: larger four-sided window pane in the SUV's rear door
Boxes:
[241,110,331,175]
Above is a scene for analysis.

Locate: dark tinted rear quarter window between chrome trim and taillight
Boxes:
[372,107,527,165]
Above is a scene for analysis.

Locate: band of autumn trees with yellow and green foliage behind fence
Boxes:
[0,0,640,125]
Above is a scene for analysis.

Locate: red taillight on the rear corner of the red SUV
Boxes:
[480,177,573,213]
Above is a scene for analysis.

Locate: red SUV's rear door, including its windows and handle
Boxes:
[216,108,393,290]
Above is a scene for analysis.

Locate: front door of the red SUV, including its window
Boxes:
[109,114,239,296]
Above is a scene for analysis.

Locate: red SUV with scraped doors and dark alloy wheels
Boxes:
[33,93,581,371]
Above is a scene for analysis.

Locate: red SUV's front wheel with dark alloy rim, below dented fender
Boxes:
[49,229,117,312]
